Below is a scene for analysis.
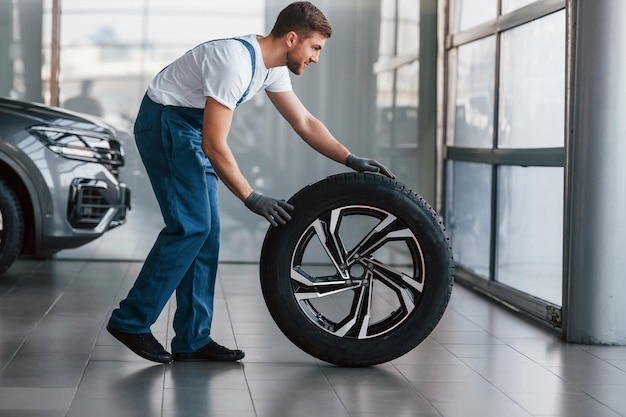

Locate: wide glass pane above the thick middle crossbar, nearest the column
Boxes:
[498,11,565,148]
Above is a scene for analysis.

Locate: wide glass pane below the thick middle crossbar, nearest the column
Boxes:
[496,167,564,305]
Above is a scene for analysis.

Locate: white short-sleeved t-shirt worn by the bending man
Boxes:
[147,34,292,110]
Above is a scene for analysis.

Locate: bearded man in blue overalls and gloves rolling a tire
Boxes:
[107,2,393,363]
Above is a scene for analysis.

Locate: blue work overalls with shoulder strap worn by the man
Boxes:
[109,39,255,353]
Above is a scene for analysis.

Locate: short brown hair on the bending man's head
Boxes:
[271,1,333,38]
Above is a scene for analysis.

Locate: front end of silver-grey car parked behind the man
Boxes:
[0,98,130,274]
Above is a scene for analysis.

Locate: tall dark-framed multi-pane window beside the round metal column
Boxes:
[444,0,566,327]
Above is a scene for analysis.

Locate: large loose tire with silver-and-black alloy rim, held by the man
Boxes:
[260,173,454,367]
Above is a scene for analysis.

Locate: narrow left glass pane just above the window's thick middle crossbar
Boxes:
[448,36,496,148]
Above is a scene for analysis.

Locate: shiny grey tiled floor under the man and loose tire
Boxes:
[0,260,626,417]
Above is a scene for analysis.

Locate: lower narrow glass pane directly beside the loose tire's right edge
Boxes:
[446,161,492,278]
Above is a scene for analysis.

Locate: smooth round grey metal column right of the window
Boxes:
[564,0,626,345]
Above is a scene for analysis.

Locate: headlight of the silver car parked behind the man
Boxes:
[29,126,124,167]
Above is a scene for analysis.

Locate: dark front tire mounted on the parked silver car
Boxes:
[0,179,24,275]
